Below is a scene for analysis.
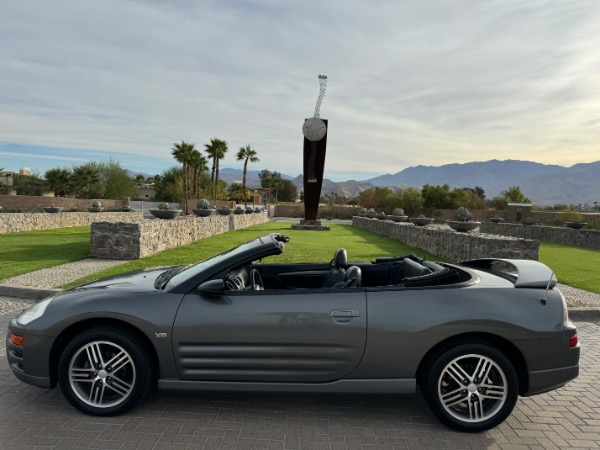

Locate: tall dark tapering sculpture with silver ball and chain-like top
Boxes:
[292,75,329,230]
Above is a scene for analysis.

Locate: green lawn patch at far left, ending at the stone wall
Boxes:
[0,226,91,280]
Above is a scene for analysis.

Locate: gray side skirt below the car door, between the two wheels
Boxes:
[158,378,417,395]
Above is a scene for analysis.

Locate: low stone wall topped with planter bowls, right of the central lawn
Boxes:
[352,217,539,261]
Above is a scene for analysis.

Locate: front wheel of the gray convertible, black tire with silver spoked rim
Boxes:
[58,327,154,416]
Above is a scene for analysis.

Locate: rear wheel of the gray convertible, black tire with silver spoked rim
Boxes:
[420,342,519,432]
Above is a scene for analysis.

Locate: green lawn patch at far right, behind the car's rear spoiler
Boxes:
[539,242,600,294]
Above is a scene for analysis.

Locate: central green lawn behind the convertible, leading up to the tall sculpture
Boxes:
[62,222,447,288]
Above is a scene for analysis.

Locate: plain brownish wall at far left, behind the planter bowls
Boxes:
[0,195,125,212]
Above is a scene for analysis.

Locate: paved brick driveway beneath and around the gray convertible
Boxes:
[0,298,600,450]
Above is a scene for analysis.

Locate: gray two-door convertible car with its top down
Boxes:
[6,234,580,431]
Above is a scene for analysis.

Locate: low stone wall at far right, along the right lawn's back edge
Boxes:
[479,222,600,249]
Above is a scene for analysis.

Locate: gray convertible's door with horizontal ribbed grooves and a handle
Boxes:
[172,289,367,382]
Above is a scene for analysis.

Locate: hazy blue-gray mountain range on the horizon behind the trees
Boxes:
[188,159,600,205]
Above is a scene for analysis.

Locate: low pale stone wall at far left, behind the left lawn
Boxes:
[0,212,143,234]
